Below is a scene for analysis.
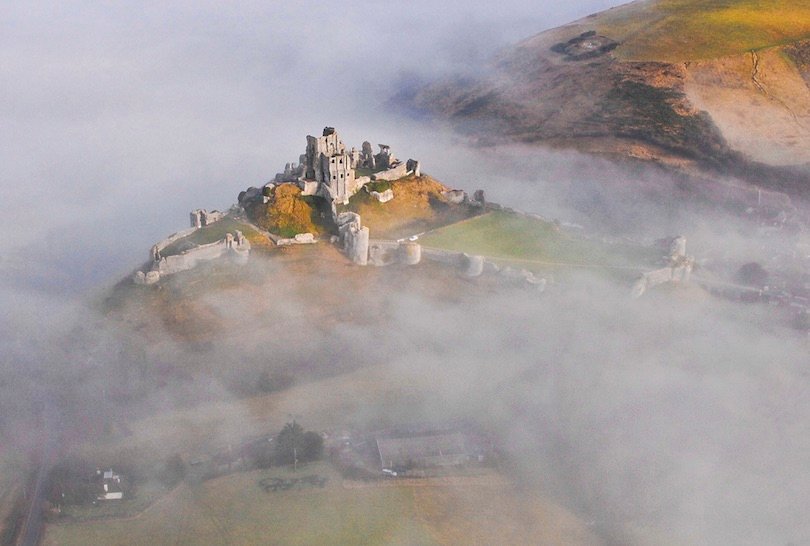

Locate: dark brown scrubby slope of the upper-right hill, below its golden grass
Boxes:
[412,23,730,165]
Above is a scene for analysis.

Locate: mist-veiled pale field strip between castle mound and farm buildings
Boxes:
[62,366,455,492]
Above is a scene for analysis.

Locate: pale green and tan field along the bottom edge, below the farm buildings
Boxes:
[44,463,599,546]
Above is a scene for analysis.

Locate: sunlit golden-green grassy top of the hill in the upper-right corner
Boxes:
[600,0,810,62]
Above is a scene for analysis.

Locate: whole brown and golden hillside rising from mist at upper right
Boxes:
[405,0,810,193]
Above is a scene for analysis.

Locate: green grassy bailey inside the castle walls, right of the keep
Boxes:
[420,211,660,270]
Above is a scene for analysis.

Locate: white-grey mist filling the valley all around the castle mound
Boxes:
[0,2,810,544]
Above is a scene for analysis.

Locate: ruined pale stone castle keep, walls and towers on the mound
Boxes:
[134,127,694,297]
